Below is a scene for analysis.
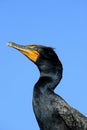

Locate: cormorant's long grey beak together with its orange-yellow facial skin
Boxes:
[8,42,40,62]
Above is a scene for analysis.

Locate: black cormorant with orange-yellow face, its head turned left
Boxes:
[8,42,87,130]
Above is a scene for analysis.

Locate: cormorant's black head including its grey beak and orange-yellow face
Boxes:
[8,42,62,74]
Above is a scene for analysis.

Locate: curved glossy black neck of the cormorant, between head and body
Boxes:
[35,68,62,92]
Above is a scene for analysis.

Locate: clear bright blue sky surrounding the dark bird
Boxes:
[0,0,87,130]
